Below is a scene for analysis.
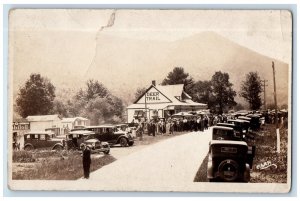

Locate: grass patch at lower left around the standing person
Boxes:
[12,151,115,180]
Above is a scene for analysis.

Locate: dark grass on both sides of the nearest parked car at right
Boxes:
[194,124,288,183]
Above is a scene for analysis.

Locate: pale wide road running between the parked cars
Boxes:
[79,130,211,191]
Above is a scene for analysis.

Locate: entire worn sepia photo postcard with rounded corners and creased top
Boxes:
[7,9,292,193]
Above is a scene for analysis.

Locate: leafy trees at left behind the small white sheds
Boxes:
[16,74,124,125]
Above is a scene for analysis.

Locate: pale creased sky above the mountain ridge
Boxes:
[10,9,292,63]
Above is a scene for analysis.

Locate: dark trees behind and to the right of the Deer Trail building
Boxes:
[135,67,262,113]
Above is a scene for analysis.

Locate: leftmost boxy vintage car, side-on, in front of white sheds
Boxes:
[24,131,65,151]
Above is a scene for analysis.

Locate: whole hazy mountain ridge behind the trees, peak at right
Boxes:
[10,30,289,105]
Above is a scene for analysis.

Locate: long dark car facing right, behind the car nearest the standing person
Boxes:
[75,125,134,147]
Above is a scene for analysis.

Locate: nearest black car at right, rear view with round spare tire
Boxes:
[207,140,253,182]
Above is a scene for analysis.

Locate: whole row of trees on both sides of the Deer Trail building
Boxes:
[15,67,262,125]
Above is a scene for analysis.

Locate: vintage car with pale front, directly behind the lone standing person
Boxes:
[66,130,110,154]
